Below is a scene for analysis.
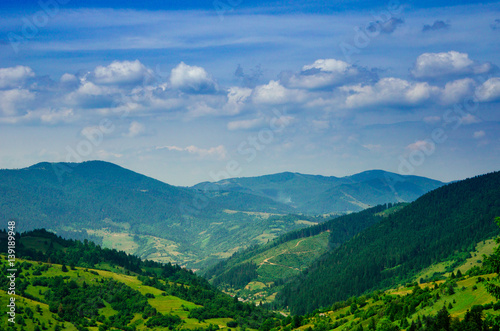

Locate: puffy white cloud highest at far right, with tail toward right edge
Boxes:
[412,51,493,78]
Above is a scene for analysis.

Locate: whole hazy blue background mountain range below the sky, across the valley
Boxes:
[0,161,443,269]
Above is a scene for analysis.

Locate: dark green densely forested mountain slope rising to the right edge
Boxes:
[276,172,500,313]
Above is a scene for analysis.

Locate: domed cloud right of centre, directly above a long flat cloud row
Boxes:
[281,59,373,90]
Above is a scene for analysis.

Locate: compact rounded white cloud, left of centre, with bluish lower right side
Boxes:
[170,62,218,93]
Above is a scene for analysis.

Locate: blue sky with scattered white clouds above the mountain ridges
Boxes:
[0,0,500,186]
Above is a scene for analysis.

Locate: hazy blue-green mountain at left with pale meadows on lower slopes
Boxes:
[0,161,316,268]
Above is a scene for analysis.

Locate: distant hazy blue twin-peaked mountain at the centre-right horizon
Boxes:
[193,170,444,214]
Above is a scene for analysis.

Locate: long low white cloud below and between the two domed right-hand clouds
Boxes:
[341,77,439,108]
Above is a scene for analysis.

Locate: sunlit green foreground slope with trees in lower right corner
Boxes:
[274,217,500,331]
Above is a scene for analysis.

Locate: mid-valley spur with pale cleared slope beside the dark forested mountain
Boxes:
[204,204,404,302]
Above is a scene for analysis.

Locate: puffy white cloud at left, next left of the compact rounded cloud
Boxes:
[91,60,153,85]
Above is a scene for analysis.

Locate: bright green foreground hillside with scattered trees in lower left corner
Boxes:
[0,230,281,331]
